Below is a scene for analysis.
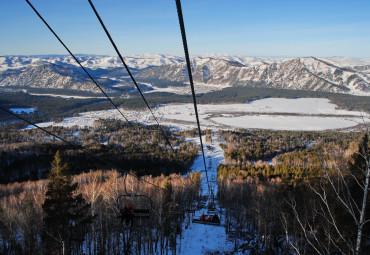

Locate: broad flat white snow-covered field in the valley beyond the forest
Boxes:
[27,98,370,131]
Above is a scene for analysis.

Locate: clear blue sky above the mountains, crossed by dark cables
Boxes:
[0,0,370,58]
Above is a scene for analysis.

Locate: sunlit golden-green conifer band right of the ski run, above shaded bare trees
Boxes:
[219,130,361,180]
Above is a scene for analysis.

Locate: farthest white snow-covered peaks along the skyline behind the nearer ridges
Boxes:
[0,53,370,71]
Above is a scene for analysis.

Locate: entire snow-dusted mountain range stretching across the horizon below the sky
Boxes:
[0,54,370,96]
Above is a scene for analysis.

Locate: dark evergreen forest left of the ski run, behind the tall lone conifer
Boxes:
[0,120,199,183]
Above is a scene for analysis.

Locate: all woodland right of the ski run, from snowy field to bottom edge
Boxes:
[218,131,370,254]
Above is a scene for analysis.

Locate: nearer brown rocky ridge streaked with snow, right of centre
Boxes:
[137,57,370,95]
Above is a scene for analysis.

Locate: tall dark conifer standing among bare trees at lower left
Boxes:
[42,151,91,255]
